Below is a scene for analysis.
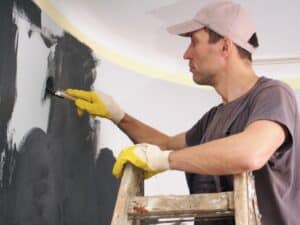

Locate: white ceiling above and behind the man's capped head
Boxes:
[36,0,300,83]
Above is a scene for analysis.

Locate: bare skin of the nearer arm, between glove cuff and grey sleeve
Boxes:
[169,120,286,175]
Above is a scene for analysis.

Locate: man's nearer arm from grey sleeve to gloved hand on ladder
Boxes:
[115,85,295,176]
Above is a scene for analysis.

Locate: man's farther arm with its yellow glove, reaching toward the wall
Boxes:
[66,89,186,150]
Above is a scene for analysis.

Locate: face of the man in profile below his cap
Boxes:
[183,29,223,86]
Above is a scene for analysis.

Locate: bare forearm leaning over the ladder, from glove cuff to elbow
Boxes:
[169,134,249,175]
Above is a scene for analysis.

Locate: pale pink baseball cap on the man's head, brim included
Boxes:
[167,1,258,53]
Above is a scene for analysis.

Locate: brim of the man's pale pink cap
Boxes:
[167,20,204,37]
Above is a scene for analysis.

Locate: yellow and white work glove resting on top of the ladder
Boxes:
[113,144,171,178]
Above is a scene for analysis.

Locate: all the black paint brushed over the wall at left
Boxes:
[0,0,119,225]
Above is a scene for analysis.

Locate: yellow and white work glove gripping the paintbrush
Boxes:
[65,89,125,124]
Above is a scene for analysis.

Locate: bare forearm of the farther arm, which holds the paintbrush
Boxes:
[118,114,170,149]
